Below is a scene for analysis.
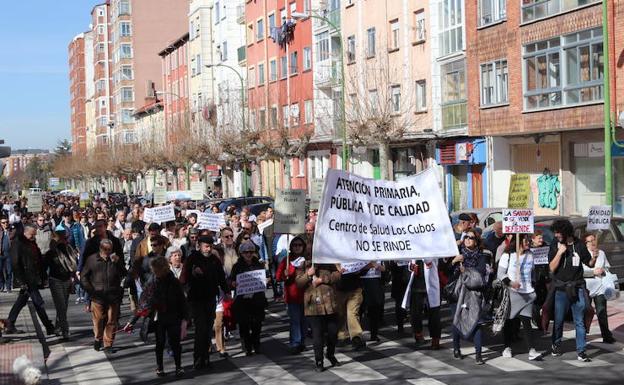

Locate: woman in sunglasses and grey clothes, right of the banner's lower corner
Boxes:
[447,230,492,365]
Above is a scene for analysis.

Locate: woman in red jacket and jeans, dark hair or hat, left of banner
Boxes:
[275,232,310,354]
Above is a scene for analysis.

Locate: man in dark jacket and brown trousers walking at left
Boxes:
[80,239,126,352]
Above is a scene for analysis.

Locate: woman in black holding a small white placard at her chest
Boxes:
[230,241,268,356]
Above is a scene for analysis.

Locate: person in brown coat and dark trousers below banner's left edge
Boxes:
[295,261,341,372]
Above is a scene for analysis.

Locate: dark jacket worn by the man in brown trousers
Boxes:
[80,253,126,305]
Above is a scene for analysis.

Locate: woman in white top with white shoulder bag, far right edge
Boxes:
[583,233,615,344]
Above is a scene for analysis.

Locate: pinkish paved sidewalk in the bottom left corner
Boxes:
[0,290,46,385]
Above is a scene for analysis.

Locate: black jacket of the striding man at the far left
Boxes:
[11,234,46,288]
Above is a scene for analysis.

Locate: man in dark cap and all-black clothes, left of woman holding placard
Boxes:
[180,236,229,369]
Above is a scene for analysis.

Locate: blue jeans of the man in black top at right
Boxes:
[552,288,585,353]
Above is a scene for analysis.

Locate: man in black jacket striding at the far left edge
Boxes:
[6,225,54,335]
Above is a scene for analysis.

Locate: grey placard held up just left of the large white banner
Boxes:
[274,190,305,234]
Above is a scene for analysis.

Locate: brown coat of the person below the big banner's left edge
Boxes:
[295,261,340,316]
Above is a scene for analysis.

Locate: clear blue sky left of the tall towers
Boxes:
[0,0,103,149]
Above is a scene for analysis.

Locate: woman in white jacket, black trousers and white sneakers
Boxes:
[497,234,542,361]
